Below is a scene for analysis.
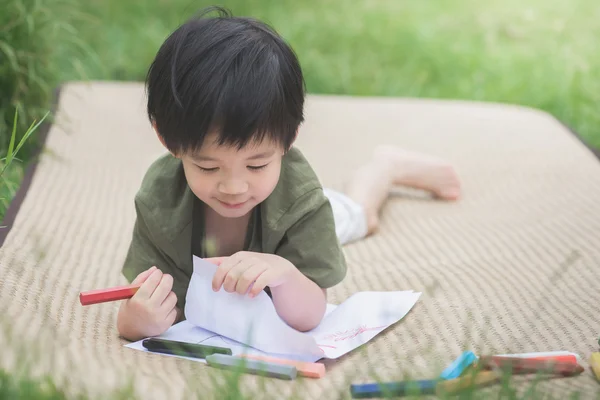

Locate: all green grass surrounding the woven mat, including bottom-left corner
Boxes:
[0,0,600,398]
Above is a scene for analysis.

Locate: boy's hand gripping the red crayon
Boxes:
[117,267,178,340]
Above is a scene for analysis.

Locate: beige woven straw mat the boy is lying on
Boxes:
[0,82,600,399]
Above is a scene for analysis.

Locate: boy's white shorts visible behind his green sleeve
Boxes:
[323,188,367,245]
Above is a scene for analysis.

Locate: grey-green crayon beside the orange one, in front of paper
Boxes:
[206,354,298,380]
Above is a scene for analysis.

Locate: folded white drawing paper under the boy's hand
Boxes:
[127,257,421,361]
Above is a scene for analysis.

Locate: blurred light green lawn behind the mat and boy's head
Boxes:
[56,0,600,146]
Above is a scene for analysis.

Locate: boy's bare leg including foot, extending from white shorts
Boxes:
[346,146,460,234]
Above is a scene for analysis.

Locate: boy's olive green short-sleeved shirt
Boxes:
[123,148,346,310]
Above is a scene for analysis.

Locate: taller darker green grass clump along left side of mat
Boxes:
[0,0,90,220]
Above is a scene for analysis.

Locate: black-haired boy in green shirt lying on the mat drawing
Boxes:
[117,8,459,340]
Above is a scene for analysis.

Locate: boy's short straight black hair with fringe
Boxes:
[146,7,305,153]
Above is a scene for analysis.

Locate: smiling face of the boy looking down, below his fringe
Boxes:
[181,137,284,218]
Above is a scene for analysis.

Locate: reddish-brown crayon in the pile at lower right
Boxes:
[479,356,583,376]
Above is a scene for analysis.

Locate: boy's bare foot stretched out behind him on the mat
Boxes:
[374,145,460,200]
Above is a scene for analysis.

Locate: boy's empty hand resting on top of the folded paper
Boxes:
[206,251,298,297]
